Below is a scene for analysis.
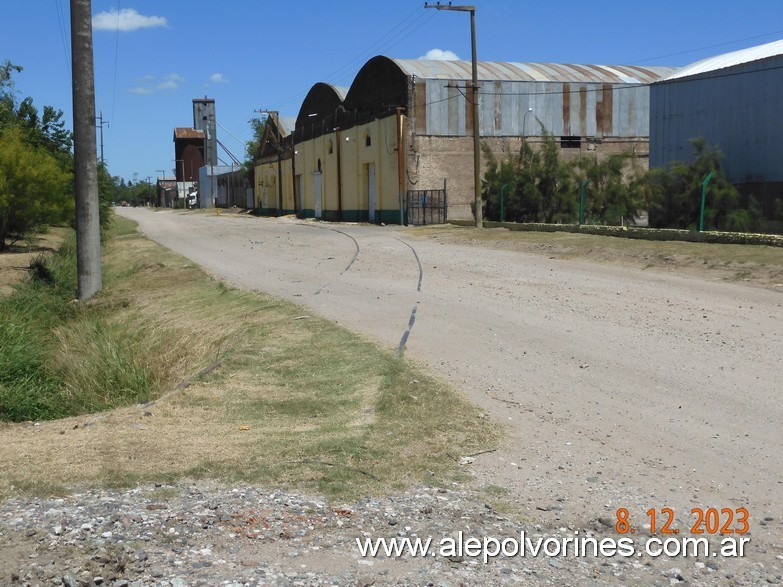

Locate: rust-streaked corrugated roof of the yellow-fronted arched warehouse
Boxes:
[392,59,677,84]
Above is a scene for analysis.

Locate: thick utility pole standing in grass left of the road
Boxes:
[71,0,103,301]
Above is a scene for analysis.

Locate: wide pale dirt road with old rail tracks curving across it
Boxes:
[120,208,783,562]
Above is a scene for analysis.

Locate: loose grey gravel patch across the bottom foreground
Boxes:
[0,481,783,587]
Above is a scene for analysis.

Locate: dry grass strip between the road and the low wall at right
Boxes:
[410,224,783,289]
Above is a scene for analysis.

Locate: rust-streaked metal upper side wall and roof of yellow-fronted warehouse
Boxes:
[393,59,675,138]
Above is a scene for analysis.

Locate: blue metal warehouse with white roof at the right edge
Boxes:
[650,40,783,229]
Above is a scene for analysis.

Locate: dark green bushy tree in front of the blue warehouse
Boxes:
[649,138,761,232]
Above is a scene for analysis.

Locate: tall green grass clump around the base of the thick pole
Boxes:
[0,227,156,422]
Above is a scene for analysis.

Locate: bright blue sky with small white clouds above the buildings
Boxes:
[0,0,783,180]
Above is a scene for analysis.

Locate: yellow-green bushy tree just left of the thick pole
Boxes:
[0,126,73,251]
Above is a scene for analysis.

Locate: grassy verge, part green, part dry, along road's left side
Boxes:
[0,219,499,499]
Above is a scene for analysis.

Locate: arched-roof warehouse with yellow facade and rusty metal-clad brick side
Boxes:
[260,56,675,223]
